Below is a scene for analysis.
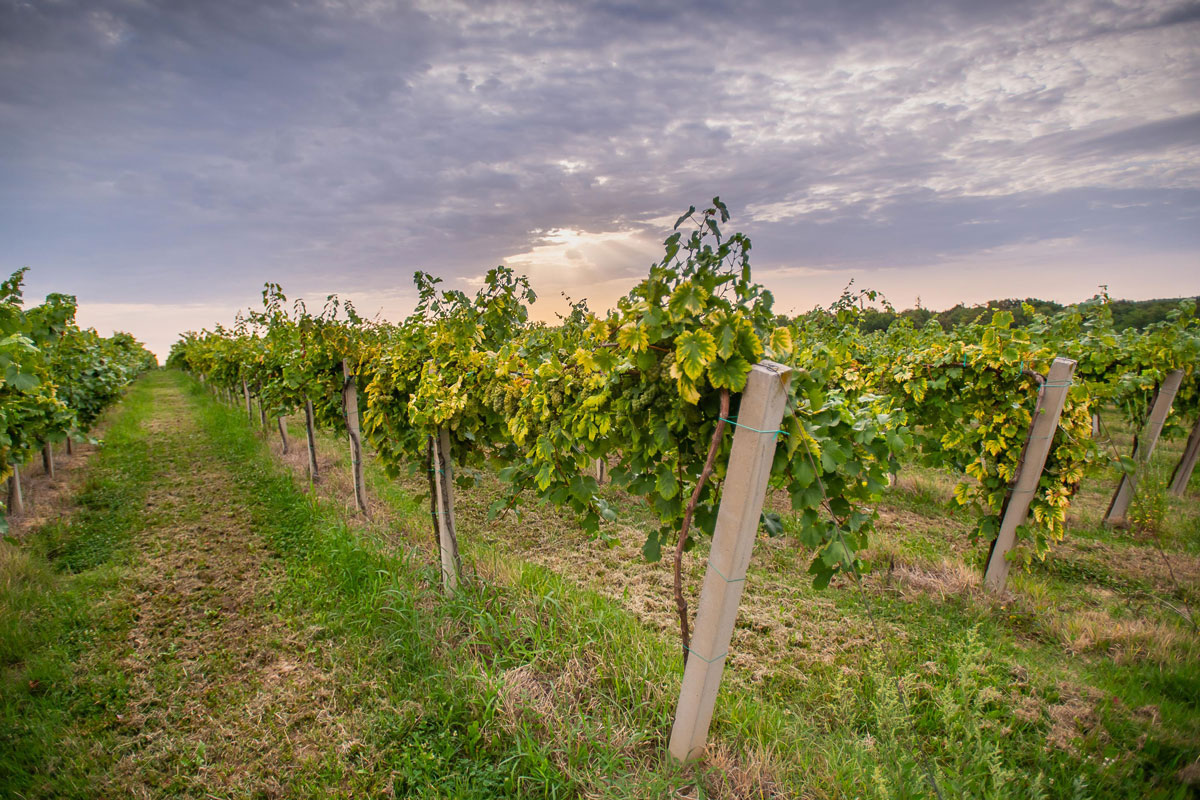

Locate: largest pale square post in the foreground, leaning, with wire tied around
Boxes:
[668,361,791,762]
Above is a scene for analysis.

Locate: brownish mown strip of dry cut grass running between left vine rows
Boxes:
[109,377,381,796]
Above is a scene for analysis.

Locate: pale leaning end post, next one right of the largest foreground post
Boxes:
[983,359,1075,594]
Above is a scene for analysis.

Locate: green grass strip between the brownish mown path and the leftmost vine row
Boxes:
[0,385,151,798]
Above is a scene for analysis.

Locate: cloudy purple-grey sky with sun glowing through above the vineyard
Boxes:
[0,0,1200,357]
